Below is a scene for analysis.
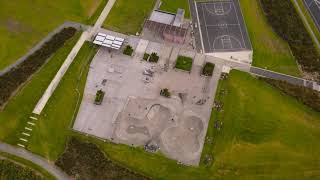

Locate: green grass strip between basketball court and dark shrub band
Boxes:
[240,0,301,76]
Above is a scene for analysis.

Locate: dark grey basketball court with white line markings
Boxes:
[196,0,251,53]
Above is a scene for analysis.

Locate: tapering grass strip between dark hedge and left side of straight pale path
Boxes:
[0,32,81,144]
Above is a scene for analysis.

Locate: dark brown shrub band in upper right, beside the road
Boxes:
[261,0,320,80]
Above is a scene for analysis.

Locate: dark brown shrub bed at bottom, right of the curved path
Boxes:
[55,138,149,180]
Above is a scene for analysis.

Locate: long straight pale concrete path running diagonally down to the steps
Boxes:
[33,0,116,115]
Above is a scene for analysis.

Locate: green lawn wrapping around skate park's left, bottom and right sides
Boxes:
[22,57,320,179]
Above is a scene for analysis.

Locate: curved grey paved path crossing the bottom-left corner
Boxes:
[0,142,69,180]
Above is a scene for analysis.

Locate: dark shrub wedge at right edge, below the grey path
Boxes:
[260,78,320,111]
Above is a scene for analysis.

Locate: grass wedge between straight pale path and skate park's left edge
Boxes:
[28,42,98,160]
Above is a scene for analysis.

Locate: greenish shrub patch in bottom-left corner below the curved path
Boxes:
[0,160,44,180]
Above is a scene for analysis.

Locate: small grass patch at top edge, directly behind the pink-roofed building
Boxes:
[160,0,190,18]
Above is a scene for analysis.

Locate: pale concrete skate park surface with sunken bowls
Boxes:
[73,44,217,165]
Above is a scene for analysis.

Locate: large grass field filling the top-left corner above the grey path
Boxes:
[0,0,104,70]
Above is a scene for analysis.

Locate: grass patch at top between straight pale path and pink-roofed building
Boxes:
[103,0,156,35]
